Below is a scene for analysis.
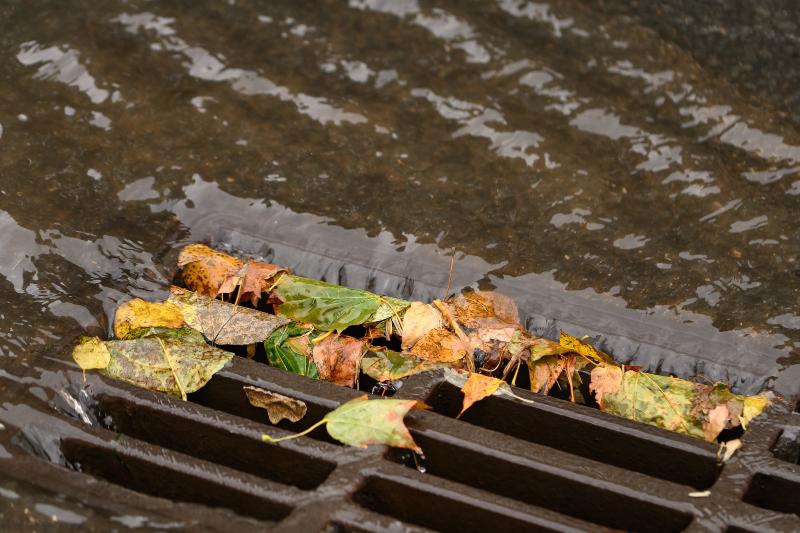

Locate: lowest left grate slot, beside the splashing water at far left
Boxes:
[61,439,292,521]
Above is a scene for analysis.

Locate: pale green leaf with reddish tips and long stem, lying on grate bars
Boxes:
[261,394,427,453]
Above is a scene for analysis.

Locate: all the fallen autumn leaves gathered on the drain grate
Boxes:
[73,244,769,450]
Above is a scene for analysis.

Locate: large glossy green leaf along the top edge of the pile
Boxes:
[272,275,410,333]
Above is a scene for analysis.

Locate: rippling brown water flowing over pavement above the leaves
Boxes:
[0,0,800,524]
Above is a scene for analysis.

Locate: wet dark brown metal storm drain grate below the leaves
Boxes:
[0,357,800,531]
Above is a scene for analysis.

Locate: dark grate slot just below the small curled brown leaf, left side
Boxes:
[97,395,336,490]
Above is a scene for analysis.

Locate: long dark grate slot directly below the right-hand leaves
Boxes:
[431,383,718,489]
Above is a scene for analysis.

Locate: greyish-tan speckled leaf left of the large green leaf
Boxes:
[168,287,289,346]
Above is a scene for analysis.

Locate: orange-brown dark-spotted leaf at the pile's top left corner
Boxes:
[178,244,243,298]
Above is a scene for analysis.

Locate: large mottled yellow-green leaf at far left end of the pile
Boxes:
[73,329,233,397]
